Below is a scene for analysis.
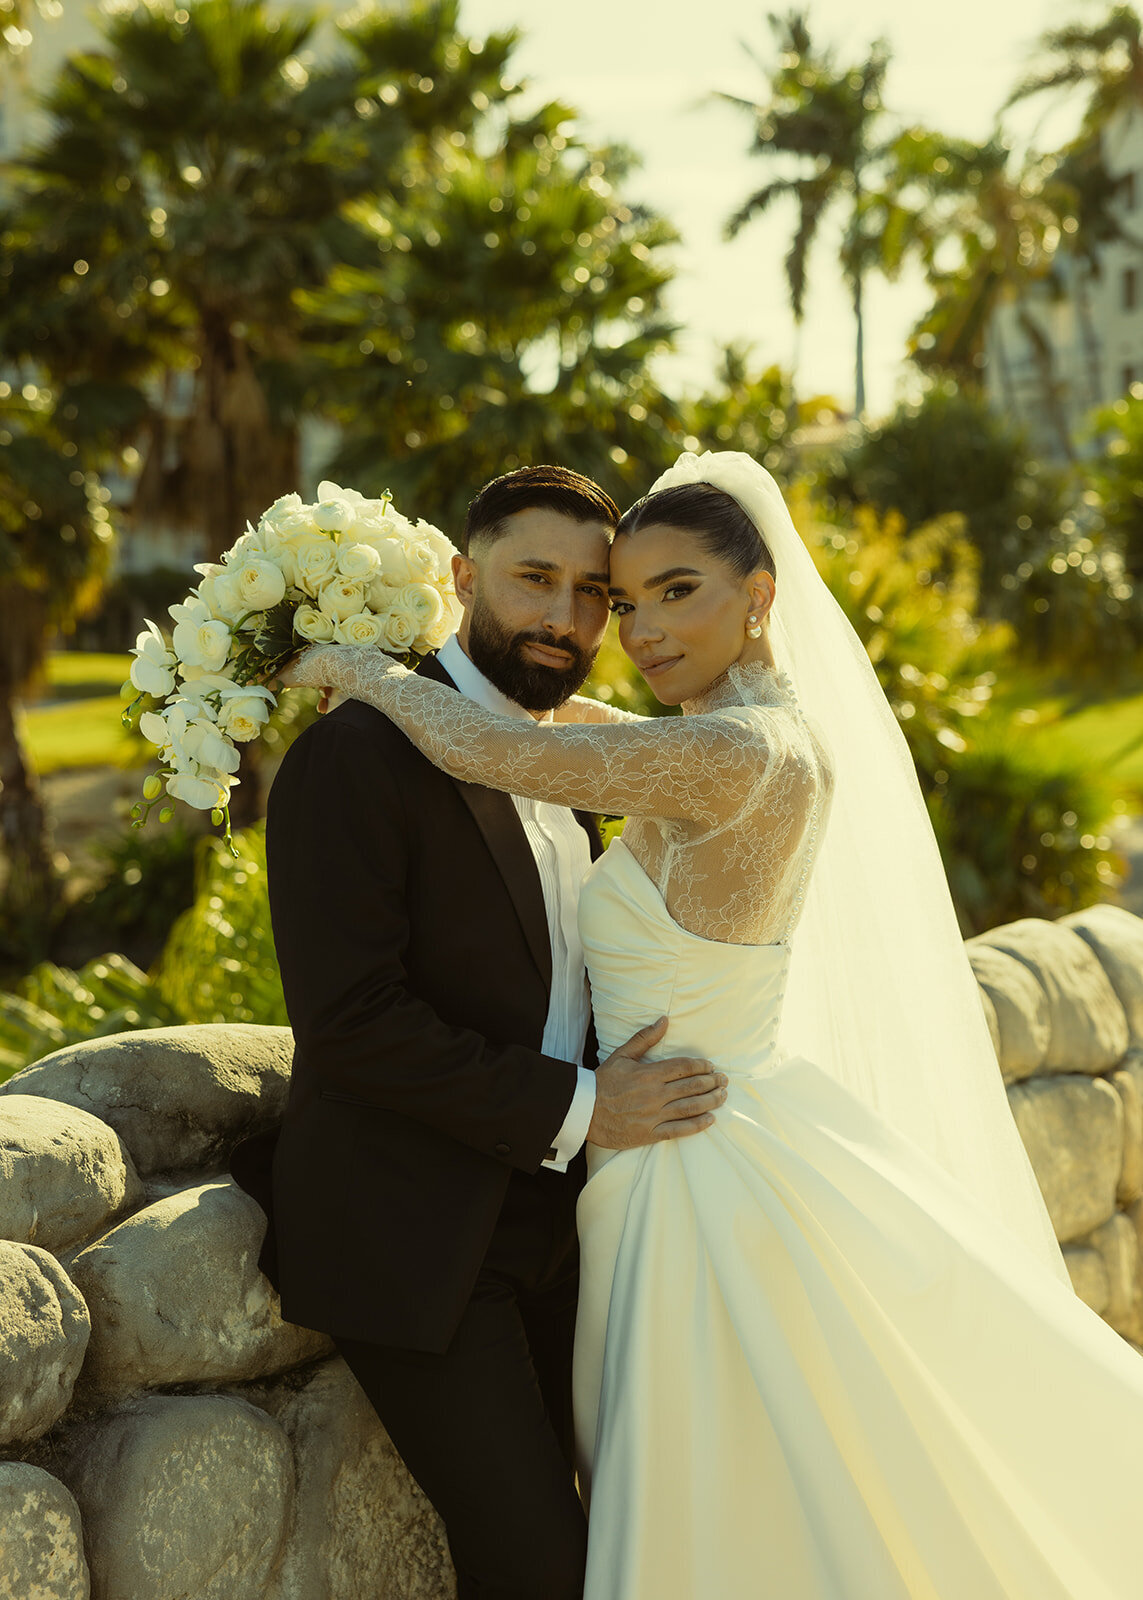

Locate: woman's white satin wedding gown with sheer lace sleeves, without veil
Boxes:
[291,646,1143,1600]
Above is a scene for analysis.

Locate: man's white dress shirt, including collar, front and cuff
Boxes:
[437,634,596,1173]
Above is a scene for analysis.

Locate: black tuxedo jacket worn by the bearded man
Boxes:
[231,659,600,1350]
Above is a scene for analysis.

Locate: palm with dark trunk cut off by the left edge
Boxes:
[0,382,110,960]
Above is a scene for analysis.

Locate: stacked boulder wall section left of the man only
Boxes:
[0,1027,455,1600]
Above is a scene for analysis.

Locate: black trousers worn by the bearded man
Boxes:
[335,1170,588,1600]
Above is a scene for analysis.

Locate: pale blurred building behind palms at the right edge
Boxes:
[985,109,1143,458]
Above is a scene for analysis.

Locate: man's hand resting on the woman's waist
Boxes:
[588,1016,728,1150]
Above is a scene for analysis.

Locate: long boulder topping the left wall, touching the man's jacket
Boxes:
[0,1024,293,1178]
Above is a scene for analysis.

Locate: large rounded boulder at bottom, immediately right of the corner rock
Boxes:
[59,1395,291,1600]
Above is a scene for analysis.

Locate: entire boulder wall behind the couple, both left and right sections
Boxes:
[0,906,1143,1600]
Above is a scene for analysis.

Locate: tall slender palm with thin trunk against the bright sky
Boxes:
[719,11,890,414]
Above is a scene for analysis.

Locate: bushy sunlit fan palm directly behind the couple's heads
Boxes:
[304,106,684,531]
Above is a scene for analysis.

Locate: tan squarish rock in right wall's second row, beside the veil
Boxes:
[1009,1075,1124,1243]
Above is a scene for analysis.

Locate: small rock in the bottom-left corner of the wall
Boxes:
[0,1461,91,1600]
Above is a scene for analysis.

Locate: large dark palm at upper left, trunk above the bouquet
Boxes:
[0,0,514,555]
